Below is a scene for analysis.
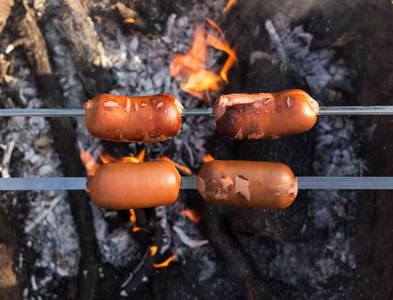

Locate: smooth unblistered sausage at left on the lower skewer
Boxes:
[87,161,181,209]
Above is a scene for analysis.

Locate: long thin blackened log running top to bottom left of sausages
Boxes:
[13,2,104,299]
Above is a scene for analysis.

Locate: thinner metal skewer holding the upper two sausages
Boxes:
[0,106,393,117]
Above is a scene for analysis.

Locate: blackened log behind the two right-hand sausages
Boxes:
[215,52,313,241]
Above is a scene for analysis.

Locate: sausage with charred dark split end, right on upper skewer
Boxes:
[213,90,319,140]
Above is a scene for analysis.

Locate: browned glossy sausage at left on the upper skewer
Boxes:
[83,94,183,143]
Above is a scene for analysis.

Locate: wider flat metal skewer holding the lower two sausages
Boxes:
[0,176,393,191]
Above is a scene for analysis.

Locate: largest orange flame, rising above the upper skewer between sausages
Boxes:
[169,18,237,104]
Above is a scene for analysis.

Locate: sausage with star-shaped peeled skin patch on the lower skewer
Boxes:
[196,160,298,209]
